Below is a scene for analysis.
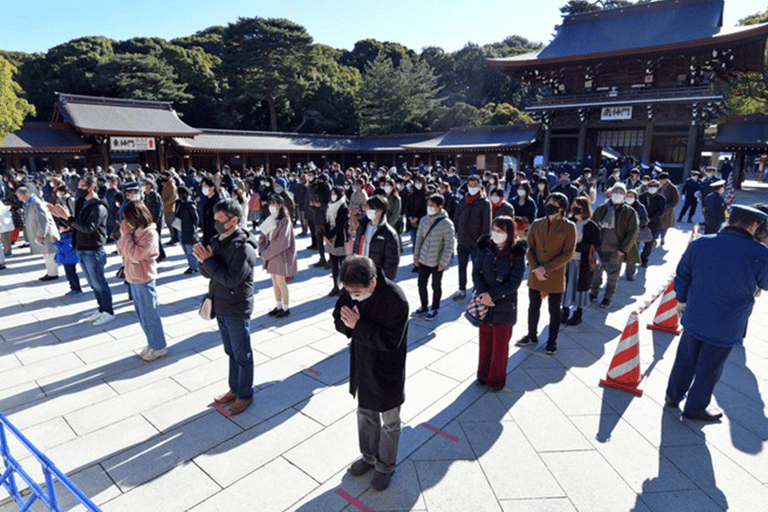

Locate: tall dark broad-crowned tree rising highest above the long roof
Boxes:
[222,18,312,131]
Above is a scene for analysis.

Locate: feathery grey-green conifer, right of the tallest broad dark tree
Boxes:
[358,54,441,134]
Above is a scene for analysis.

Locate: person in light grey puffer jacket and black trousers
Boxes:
[413,194,454,321]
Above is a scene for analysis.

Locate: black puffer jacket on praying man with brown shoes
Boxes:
[200,228,258,319]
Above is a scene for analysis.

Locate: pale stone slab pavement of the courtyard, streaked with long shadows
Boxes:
[0,189,768,512]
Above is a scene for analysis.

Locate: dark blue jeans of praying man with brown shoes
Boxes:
[216,316,253,398]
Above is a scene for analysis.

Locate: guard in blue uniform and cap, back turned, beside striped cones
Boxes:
[665,205,768,421]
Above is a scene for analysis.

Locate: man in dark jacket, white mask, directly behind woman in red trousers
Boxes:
[453,174,491,300]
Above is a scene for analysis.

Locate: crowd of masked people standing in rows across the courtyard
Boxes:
[0,157,768,489]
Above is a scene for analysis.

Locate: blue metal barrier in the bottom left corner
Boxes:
[0,414,101,512]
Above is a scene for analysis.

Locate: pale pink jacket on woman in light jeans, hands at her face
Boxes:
[117,222,160,284]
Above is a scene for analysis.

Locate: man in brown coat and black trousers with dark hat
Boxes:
[517,192,576,355]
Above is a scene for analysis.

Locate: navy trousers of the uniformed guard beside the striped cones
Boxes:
[667,329,733,416]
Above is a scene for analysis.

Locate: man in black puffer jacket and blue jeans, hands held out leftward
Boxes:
[49,175,115,326]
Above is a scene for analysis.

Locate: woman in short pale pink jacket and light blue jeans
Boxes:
[117,201,166,362]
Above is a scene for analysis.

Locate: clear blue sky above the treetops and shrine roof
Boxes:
[0,0,768,52]
